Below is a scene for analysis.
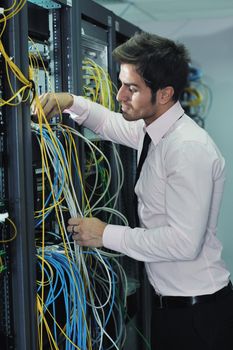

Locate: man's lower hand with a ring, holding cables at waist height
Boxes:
[67,217,107,248]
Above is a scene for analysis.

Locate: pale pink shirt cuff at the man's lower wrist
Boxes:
[103,224,128,253]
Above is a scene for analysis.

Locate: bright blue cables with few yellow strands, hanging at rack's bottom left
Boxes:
[38,250,90,349]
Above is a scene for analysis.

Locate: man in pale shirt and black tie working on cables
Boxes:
[41,33,233,350]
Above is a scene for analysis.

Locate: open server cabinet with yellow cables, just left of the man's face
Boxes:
[70,0,121,222]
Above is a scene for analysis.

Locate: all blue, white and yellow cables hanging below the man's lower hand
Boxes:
[38,247,126,349]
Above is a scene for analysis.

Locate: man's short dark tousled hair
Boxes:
[113,32,190,101]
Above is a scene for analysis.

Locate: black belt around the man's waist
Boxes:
[152,282,233,309]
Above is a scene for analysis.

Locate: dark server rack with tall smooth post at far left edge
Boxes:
[1,1,36,349]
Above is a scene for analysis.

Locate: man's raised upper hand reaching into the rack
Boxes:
[35,92,74,120]
